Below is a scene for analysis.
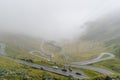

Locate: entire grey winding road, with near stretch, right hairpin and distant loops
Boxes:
[0,38,117,79]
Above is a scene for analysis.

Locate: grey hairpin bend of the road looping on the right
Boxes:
[29,42,115,74]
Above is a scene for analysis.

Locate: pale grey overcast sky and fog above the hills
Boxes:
[0,0,120,40]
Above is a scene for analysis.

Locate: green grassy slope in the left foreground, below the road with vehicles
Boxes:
[0,56,72,80]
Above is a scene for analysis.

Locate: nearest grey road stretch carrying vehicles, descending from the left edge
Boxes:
[0,44,88,79]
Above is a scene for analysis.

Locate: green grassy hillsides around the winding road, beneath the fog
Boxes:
[0,11,120,80]
